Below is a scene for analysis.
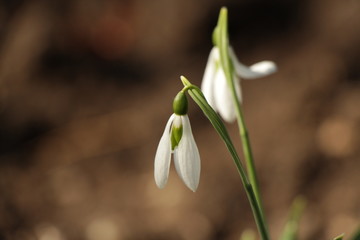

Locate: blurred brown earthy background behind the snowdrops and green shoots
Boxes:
[0,0,360,240]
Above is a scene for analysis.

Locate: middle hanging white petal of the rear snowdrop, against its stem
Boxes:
[215,69,240,122]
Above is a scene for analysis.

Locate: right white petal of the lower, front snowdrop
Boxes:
[174,115,200,192]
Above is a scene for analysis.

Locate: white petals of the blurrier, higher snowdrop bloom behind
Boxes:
[201,47,277,122]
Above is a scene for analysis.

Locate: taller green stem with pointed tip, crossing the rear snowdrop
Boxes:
[217,8,266,232]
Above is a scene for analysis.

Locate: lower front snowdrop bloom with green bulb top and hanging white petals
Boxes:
[154,92,200,192]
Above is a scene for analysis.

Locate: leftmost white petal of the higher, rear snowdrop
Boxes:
[201,47,219,108]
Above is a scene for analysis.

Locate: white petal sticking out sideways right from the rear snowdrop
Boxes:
[229,48,277,79]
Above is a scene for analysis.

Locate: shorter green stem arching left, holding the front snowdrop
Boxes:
[181,76,269,240]
